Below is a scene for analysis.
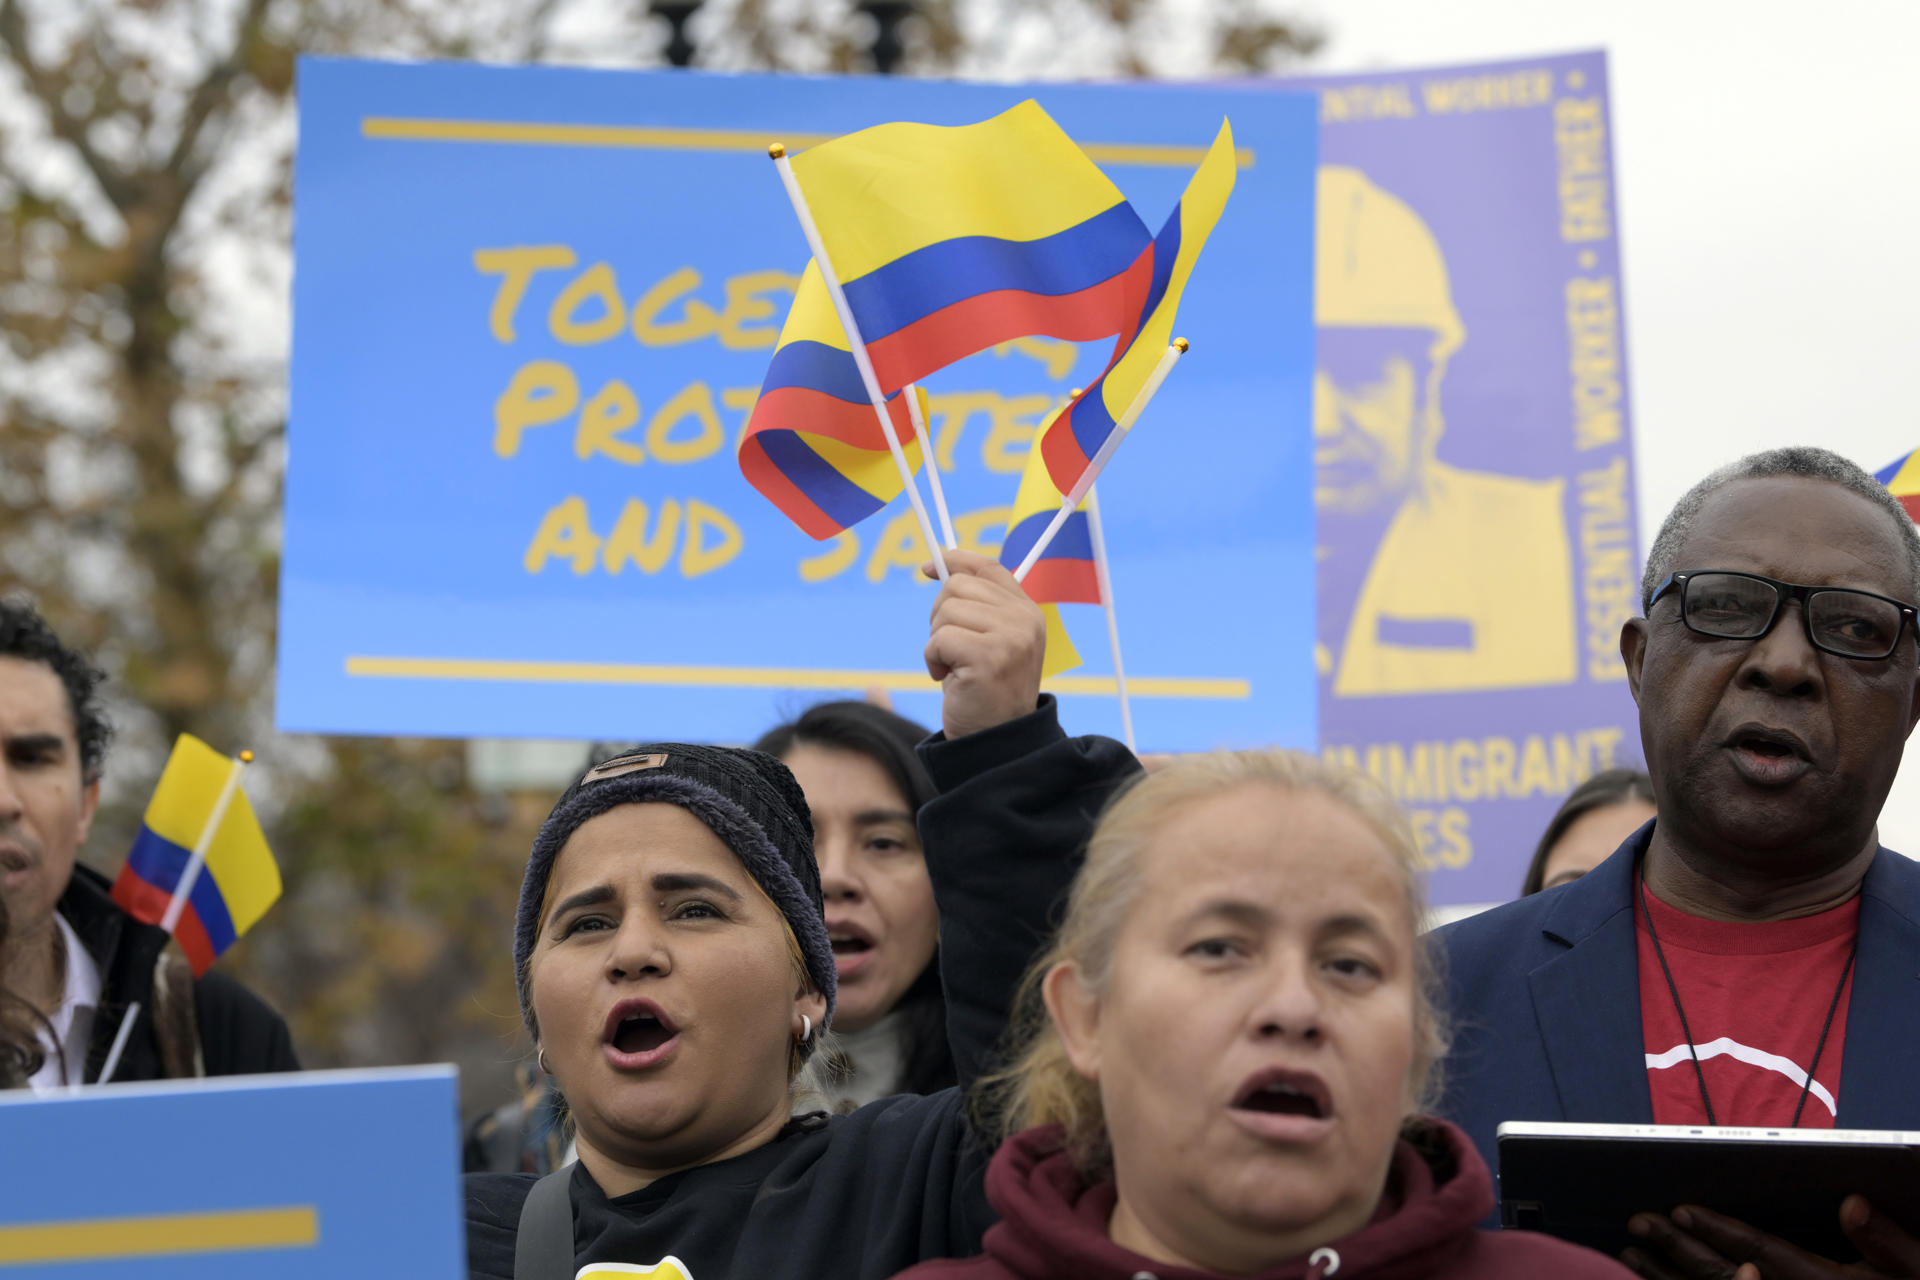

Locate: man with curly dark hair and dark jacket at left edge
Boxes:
[0,599,300,1090]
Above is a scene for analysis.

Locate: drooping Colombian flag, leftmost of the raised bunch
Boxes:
[739,263,927,539]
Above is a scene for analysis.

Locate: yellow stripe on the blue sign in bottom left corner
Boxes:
[0,1205,321,1267]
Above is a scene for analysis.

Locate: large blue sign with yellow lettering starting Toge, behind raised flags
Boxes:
[276,59,1317,748]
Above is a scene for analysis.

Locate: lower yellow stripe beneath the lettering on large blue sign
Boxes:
[348,656,1254,702]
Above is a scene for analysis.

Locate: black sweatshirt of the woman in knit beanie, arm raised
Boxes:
[467,697,1131,1280]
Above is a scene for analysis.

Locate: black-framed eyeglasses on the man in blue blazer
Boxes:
[1647,568,1920,660]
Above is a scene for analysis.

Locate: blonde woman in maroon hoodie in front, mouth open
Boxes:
[902,752,1630,1280]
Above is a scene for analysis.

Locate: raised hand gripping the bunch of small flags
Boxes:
[920,551,1046,739]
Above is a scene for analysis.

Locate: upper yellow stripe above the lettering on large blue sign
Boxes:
[361,115,1254,169]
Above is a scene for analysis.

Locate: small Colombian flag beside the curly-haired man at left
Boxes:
[113,733,280,977]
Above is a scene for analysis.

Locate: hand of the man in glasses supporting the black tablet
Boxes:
[1620,1196,1920,1280]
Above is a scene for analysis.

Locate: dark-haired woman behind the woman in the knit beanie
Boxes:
[753,702,956,1111]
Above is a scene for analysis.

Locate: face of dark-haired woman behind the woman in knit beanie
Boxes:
[783,743,939,1031]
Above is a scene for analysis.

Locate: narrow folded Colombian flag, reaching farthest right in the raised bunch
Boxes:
[1039,121,1235,493]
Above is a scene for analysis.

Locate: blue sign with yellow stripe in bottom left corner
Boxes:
[0,1067,467,1280]
